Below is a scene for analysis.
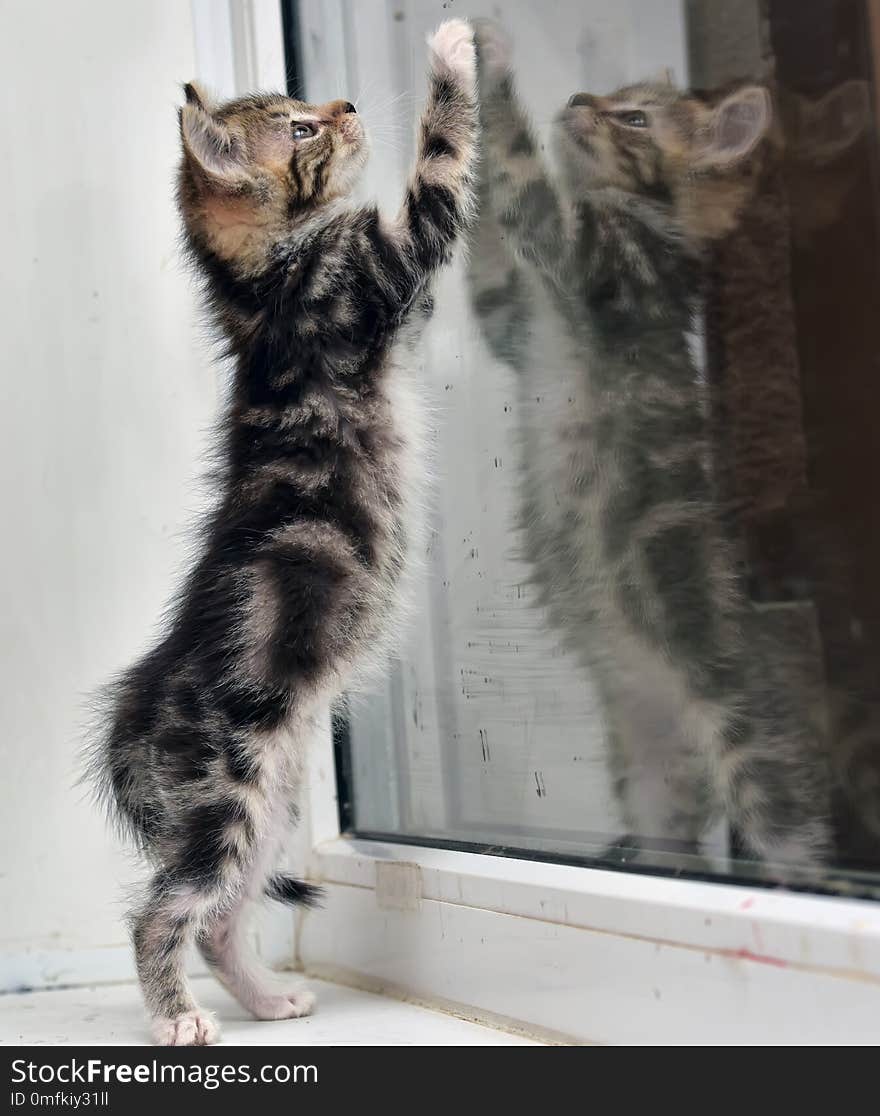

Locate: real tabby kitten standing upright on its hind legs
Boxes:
[86,20,477,1046]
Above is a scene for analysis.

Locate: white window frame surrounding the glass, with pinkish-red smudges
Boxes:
[217,0,880,1045]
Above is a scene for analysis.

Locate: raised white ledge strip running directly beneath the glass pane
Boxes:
[315,837,880,982]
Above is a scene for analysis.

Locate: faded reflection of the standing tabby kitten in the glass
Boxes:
[470,23,829,865]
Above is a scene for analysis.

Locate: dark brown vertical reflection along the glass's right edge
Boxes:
[771,0,880,865]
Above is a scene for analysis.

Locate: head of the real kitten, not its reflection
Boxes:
[178,84,367,272]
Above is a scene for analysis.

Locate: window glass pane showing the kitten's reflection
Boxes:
[300,0,880,891]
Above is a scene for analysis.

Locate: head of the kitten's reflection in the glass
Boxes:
[558,84,772,241]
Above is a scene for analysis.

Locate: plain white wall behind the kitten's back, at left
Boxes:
[0,0,219,988]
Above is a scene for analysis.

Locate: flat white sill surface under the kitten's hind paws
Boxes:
[0,979,542,1047]
